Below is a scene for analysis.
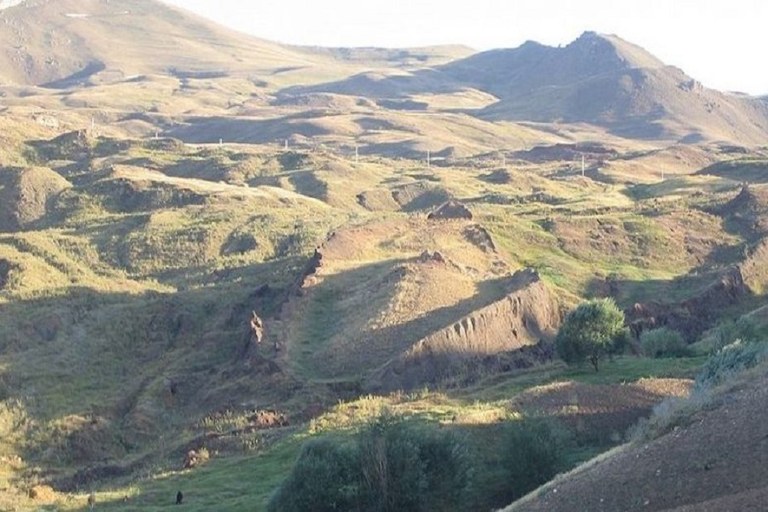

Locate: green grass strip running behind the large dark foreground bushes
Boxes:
[79,356,705,511]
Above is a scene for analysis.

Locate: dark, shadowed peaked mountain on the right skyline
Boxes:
[445,32,768,143]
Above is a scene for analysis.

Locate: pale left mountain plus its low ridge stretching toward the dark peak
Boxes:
[0,0,470,87]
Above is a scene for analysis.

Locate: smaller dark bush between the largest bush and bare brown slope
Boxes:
[499,419,573,503]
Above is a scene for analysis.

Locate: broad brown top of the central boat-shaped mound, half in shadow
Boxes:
[274,217,520,380]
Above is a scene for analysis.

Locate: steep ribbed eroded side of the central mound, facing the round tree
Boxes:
[369,269,561,390]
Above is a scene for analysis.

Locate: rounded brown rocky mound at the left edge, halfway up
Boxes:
[0,167,71,231]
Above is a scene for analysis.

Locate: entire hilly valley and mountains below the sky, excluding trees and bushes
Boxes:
[0,0,768,511]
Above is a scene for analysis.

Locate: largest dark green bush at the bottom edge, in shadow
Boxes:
[269,415,472,512]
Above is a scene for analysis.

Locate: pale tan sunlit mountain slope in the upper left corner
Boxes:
[0,0,332,85]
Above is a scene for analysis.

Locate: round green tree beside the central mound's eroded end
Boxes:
[555,299,629,371]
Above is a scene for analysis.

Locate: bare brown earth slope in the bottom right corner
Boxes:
[505,368,768,512]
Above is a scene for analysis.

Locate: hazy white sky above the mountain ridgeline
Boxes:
[166,0,768,94]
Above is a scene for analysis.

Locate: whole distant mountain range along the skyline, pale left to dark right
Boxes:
[0,0,768,144]
